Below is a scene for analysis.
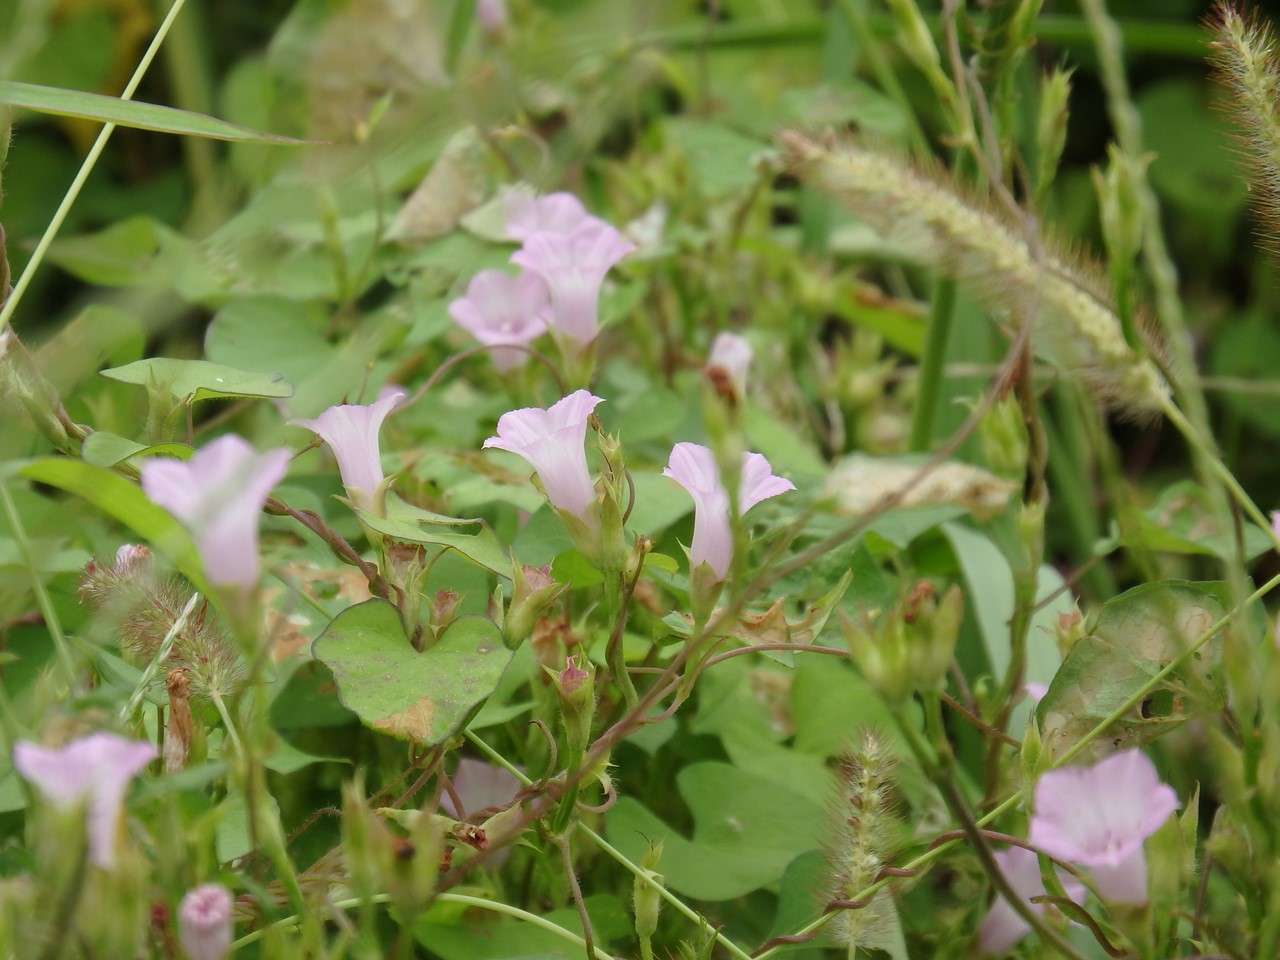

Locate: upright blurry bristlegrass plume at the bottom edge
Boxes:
[822,731,899,956]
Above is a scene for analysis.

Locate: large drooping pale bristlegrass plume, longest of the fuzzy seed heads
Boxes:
[782,132,1169,419]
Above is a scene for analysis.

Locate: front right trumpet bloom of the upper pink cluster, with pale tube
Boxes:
[511,216,635,348]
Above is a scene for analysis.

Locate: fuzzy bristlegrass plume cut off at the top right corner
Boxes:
[1210,3,1280,257]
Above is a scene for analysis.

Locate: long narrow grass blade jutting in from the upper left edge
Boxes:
[0,81,316,145]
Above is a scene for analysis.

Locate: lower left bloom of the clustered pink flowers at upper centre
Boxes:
[449,270,550,370]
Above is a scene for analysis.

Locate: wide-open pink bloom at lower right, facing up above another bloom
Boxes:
[1029,750,1179,905]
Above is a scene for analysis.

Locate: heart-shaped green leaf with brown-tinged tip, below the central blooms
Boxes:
[311,600,512,745]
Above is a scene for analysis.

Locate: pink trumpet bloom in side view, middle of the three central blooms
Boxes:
[484,390,604,522]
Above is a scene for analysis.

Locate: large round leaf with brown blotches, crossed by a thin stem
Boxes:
[1036,581,1226,760]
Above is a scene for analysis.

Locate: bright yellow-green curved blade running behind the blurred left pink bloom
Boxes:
[18,457,211,595]
